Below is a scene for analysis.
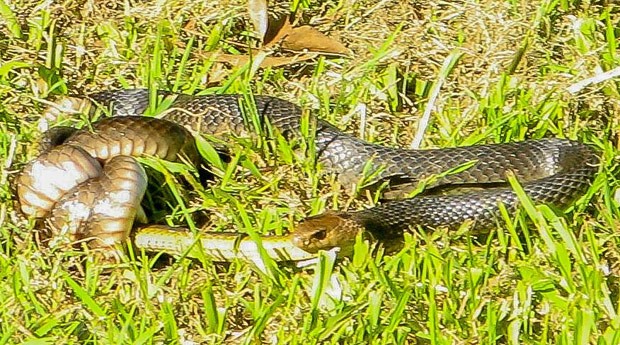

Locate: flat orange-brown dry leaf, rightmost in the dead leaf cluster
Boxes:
[282,25,349,55]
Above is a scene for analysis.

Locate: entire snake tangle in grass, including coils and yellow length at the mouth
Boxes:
[16,89,599,260]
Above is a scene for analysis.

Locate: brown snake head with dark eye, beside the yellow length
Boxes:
[292,212,364,255]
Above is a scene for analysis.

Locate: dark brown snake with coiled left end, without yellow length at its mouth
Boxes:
[17,89,599,258]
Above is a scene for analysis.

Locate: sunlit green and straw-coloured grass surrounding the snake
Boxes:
[0,0,620,344]
